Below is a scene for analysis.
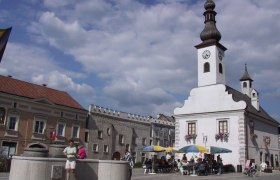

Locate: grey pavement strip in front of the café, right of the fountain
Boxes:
[131,168,280,180]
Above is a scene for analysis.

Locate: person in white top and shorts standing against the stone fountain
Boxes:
[63,139,77,180]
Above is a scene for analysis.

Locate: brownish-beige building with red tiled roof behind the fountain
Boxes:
[0,76,87,156]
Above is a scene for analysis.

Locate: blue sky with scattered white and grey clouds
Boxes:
[0,0,280,121]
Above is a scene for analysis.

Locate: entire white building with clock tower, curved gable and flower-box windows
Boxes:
[174,0,280,168]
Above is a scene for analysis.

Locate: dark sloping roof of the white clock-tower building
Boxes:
[226,86,280,125]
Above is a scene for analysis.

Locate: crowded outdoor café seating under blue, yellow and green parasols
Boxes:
[141,145,232,176]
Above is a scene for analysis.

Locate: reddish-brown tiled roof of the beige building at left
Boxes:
[0,75,85,110]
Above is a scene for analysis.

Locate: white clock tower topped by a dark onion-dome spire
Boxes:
[195,0,227,87]
